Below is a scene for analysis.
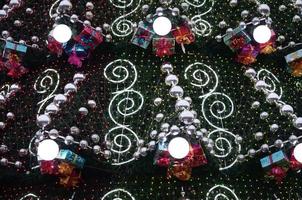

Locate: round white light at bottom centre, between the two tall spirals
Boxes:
[168,137,190,159]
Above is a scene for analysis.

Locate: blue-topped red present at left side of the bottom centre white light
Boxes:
[154,142,171,167]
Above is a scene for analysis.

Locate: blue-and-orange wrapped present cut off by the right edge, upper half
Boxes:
[285,49,302,77]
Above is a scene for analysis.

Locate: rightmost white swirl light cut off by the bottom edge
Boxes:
[206,185,239,200]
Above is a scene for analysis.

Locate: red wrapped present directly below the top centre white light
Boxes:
[153,37,175,58]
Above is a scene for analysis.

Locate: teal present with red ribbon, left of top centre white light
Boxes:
[131,23,154,49]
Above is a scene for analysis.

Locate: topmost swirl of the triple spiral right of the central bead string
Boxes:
[184,62,218,98]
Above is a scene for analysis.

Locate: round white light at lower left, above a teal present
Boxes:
[38,139,59,160]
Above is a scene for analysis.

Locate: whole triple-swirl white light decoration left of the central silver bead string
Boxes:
[104,59,144,165]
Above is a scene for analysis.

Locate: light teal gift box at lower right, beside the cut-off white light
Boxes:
[260,150,288,168]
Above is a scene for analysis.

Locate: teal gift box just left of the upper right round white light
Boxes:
[223,27,252,51]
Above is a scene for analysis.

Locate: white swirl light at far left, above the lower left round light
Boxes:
[34,69,60,115]
